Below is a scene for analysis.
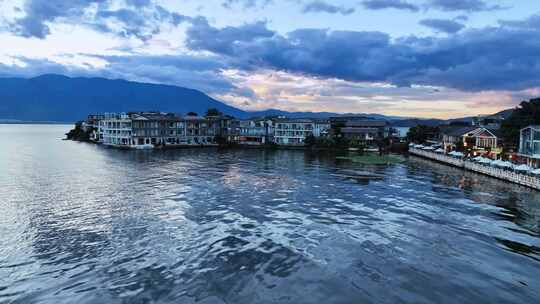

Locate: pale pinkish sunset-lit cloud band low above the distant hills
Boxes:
[216,70,524,118]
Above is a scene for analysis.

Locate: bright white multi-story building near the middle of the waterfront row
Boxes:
[274,118,315,146]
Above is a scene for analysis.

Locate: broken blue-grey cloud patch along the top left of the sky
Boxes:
[8,0,188,39]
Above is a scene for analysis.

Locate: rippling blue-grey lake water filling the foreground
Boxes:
[0,125,540,304]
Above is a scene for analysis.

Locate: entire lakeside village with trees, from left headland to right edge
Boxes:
[67,100,540,171]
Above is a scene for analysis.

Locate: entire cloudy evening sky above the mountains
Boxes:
[0,0,540,118]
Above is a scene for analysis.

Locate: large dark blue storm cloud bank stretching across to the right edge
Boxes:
[186,16,540,91]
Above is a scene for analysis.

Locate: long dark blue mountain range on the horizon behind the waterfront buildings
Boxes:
[0,74,508,126]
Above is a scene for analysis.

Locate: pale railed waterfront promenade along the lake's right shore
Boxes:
[409,147,540,190]
